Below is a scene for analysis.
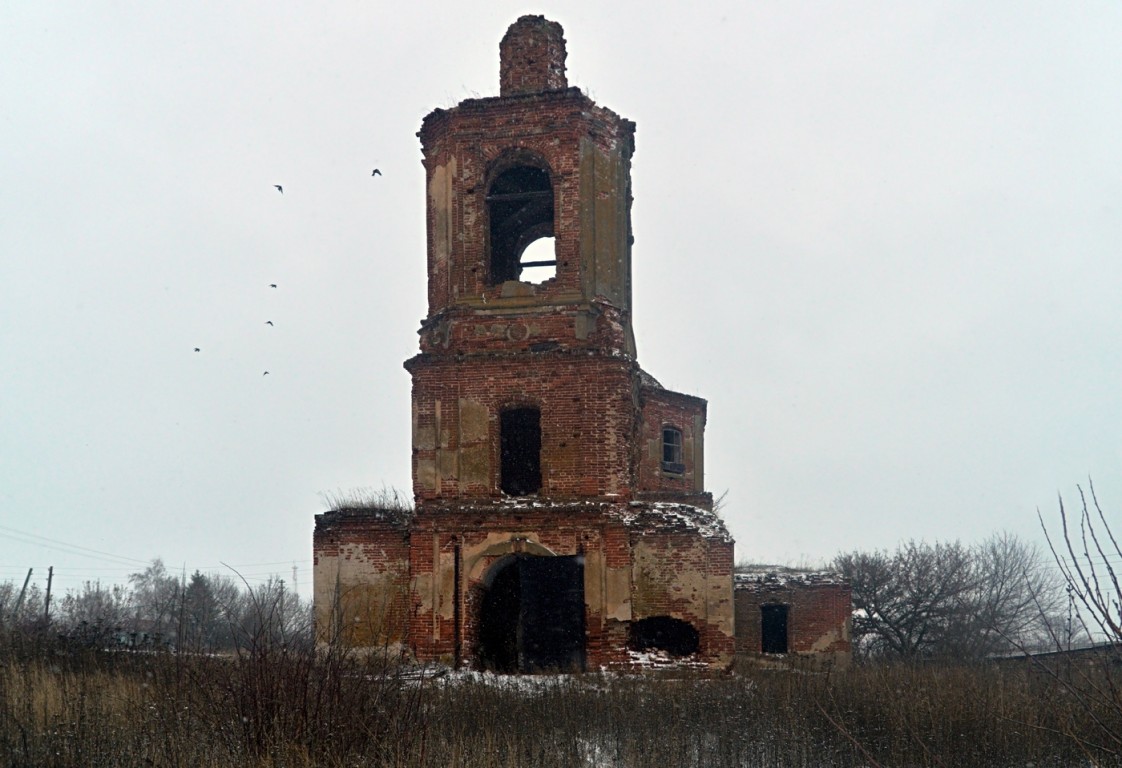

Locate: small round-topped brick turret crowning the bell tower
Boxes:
[499,16,569,97]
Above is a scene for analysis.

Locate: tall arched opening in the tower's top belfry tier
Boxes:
[487,165,557,285]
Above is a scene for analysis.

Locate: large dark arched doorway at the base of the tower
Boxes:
[479,555,585,673]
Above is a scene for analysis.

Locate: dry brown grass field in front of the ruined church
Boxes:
[0,638,1122,768]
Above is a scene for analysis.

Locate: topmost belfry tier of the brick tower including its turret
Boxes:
[417,16,635,356]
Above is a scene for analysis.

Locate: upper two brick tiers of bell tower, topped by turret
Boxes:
[406,16,650,501]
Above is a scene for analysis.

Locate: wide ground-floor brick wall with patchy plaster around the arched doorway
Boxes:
[314,503,733,669]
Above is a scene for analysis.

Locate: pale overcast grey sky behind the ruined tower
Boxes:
[0,0,1122,593]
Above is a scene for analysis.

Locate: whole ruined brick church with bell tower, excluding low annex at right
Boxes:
[314,16,848,671]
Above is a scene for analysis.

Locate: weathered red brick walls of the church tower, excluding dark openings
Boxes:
[314,17,734,668]
